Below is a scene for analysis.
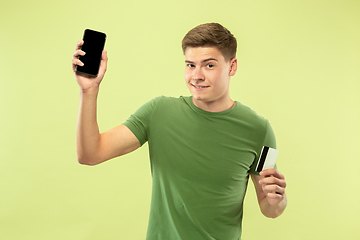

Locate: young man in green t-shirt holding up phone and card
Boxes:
[72,23,287,240]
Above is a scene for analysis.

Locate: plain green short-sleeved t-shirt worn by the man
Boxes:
[124,96,276,240]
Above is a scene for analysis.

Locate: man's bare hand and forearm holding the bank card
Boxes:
[250,168,287,218]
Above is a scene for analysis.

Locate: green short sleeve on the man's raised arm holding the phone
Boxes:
[123,98,158,145]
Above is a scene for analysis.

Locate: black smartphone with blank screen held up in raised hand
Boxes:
[76,29,106,77]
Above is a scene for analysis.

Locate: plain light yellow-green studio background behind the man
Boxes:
[0,0,360,240]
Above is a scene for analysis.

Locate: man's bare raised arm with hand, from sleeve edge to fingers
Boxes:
[72,41,140,165]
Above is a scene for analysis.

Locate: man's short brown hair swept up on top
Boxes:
[182,23,237,61]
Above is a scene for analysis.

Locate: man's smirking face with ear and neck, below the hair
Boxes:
[185,47,237,107]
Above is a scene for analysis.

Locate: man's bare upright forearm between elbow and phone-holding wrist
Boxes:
[76,87,100,165]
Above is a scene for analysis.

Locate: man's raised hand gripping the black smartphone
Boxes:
[71,40,108,91]
